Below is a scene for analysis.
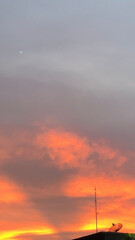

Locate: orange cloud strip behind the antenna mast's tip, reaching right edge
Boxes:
[63,176,135,199]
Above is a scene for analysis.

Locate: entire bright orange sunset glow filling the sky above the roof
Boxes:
[0,128,135,237]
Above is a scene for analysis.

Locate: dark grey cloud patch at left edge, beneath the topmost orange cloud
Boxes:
[1,160,76,189]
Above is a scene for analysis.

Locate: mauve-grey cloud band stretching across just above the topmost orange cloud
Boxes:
[0,78,135,153]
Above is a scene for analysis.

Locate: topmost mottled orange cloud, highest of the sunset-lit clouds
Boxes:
[0,126,127,171]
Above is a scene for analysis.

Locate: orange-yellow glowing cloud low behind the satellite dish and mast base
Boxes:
[78,198,135,232]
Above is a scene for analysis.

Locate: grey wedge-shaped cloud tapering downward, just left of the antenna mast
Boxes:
[31,196,93,228]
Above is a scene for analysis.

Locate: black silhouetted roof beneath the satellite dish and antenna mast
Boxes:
[72,232,135,240]
